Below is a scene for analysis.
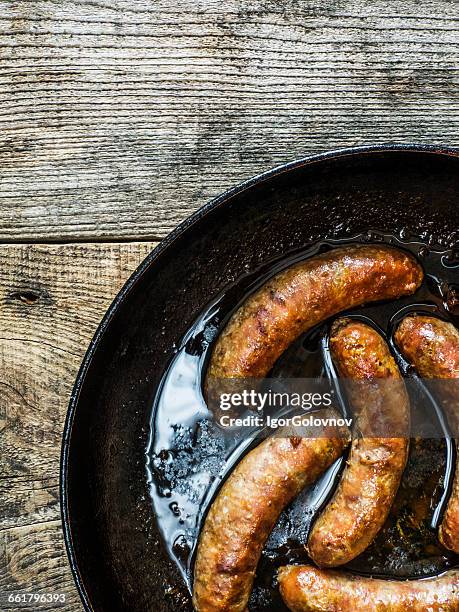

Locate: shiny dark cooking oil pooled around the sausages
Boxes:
[147,232,459,610]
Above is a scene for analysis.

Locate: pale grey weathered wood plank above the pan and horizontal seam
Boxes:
[0,0,459,241]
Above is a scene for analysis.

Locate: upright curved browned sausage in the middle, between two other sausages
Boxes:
[307,319,409,567]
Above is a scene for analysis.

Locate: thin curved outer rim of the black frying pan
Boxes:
[59,143,459,612]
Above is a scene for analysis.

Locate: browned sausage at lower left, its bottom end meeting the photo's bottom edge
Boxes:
[193,424,348,612]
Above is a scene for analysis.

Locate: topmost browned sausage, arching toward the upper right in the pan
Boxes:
[208,245,423,378]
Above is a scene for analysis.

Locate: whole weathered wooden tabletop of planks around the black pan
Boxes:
[0,0,459,611]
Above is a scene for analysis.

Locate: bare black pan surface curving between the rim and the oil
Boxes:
[61,147,459,612]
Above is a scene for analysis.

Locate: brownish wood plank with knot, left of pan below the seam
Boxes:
[0,243,154,611]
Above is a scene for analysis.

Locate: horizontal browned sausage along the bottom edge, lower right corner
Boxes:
[278,565,459,612]
